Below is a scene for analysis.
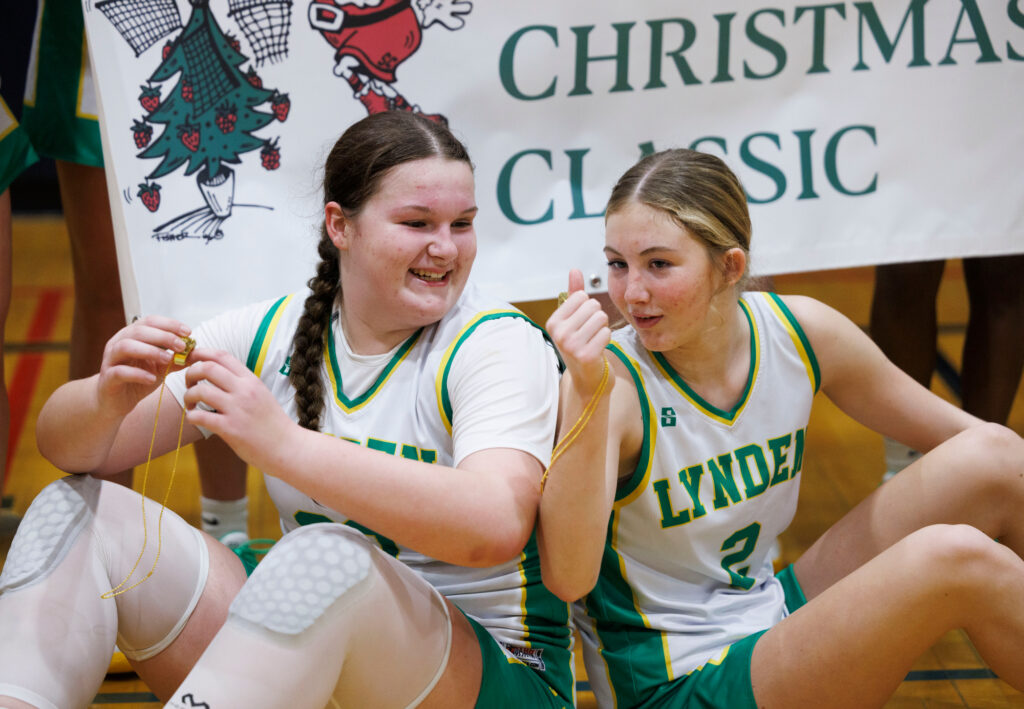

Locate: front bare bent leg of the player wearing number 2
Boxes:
[751,522,1024,709]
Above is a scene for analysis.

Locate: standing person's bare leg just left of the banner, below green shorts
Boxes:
[56,160,132,488]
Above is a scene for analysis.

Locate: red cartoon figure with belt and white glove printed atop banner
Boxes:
[309,0,473,124]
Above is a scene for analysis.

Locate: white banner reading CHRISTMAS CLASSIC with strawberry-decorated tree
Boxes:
[84,0,1024,323]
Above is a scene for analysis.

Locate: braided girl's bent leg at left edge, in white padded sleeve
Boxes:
[0,475,209,709]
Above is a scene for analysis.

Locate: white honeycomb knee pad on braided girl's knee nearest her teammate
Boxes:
[229,524,371,635]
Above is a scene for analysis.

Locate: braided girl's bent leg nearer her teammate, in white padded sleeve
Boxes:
[167,524,452,709]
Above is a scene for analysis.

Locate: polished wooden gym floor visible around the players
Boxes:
[0,215,1024,709]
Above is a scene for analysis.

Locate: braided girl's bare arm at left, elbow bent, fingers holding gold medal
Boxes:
[36,317,199,476]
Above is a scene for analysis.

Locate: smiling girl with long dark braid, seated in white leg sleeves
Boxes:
[0,112,572,708]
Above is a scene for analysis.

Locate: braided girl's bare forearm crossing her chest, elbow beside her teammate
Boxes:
[184,317,557,567]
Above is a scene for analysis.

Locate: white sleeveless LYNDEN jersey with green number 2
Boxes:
[578,293,820,707]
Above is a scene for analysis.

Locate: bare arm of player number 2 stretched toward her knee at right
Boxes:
[783,296,982,452]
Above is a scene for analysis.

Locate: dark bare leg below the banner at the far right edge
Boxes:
[961,254,1024,423]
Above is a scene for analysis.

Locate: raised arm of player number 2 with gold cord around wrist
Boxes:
[538,270,629,601]
